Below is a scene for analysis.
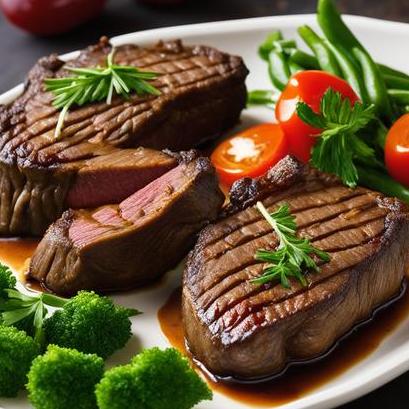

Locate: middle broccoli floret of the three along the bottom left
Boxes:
[27,345,104,409]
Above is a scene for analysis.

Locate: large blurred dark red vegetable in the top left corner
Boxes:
[0,0,106,35]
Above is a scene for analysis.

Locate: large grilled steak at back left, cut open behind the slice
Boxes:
[0,38,247,235]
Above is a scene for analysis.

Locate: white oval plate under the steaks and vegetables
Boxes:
[0,15,409,409]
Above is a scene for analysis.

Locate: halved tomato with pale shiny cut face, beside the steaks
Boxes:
[211,123,288,186]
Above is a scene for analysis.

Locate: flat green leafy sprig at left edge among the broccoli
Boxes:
[0,286,66,345]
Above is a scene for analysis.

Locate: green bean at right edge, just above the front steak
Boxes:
[357,165,409,203]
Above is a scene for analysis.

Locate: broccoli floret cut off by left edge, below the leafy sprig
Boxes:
[0,325,40,397]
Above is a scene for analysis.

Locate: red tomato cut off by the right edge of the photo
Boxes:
[385,114,409,186]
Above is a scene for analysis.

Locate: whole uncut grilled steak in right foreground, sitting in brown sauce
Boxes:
[183,157,409,380]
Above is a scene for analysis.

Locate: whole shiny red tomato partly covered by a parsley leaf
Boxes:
[276,70,359,162]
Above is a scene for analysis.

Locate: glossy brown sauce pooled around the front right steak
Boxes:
[158,288,409,407]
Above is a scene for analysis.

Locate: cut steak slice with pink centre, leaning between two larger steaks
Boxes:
[29,156,224,294]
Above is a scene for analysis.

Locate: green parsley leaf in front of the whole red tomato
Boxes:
[297,88,377,187]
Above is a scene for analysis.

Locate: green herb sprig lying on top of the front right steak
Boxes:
[251,202,329,288]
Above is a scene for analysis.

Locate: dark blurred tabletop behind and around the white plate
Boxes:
[0,0,409,409]
